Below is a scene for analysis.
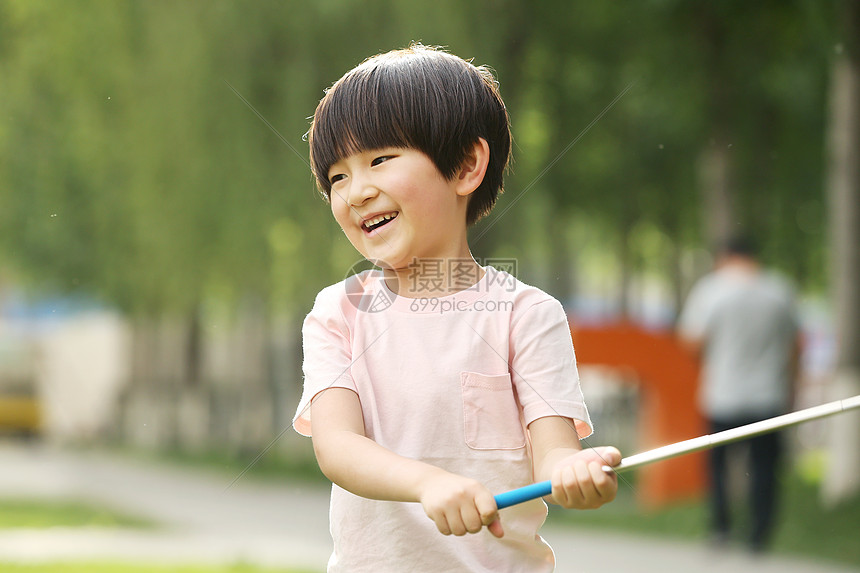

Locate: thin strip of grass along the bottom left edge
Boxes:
[0,561,320,573]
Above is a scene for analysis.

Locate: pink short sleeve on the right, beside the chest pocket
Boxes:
[510,298,592,439]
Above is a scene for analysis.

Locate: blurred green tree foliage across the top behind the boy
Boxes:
[0,0,835,315]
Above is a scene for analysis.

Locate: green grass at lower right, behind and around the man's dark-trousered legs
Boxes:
[550,474,860,567]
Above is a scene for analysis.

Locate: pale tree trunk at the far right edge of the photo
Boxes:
[822,1,860,505]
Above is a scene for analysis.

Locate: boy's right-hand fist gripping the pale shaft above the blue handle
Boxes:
[551,447,621,509]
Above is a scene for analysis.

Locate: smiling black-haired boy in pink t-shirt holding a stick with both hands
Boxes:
[293,45,621,573]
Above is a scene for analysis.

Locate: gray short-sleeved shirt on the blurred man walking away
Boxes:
[679,266,798,418]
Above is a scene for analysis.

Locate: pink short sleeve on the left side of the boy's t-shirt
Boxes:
[293,287,356,437]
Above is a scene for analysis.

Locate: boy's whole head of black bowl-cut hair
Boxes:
[308,44,511,225]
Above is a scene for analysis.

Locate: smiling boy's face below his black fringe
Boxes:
[328,147,469,270]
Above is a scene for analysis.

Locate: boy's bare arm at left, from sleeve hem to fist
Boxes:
[311,388,503,537]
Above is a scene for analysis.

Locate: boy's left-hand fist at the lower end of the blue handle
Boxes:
[419,473,504,537]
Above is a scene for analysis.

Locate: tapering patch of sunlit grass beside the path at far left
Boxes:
[0,499,155,528]
